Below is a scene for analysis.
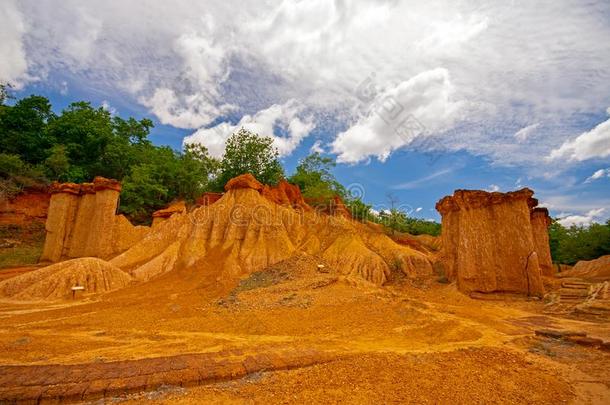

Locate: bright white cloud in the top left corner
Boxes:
[0,0,28,88]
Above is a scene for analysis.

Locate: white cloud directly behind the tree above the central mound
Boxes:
[184,100,315,157]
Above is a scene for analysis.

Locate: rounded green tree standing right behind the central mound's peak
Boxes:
[215,128,284,189]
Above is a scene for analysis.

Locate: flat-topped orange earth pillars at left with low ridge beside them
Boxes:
[40,177,149,262]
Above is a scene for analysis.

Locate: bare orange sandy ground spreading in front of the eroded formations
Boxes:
[0,260,610,404]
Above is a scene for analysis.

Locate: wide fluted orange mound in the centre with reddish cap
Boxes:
[111,175,432,284]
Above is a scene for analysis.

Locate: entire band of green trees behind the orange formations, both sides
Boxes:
[0,85,610,264]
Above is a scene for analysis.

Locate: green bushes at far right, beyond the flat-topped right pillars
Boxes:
[549,220,610,265]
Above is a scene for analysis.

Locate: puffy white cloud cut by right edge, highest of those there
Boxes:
[548,113,610,162]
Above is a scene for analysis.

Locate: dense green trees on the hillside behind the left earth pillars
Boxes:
[0,90,219,221]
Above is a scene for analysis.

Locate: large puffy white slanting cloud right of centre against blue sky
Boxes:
[332,68,462,163]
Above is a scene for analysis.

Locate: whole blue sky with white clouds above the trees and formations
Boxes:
[0,0,610,224]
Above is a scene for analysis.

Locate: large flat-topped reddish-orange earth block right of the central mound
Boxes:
[436,188,550,296]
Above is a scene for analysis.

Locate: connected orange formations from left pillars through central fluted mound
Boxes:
[21,175,433,299]
